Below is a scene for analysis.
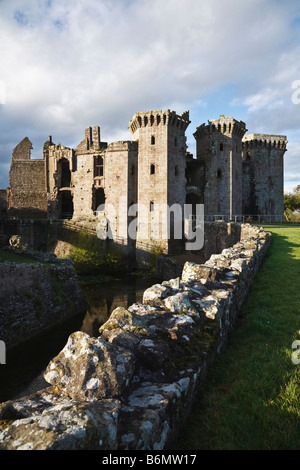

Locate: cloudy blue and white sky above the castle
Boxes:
[0,0,300,192]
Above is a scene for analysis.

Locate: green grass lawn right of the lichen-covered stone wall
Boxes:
[176,227,300,450]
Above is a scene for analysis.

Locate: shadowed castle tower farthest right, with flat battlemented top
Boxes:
[242,134,287,221]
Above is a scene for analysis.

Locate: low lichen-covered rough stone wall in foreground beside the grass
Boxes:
[0,225,271,450]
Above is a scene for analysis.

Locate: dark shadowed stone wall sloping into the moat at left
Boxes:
[0,255,87,349]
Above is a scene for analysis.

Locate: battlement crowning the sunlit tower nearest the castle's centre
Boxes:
[128,109,191,134]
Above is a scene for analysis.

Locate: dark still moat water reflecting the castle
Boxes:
[0,278,157,402]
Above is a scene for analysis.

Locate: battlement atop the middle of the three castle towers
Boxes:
[194,114,247,140]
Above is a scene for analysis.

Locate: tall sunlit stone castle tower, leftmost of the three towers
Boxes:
[129,110,190,253]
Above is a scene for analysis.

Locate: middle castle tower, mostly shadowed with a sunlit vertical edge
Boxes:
[194,115,246,220]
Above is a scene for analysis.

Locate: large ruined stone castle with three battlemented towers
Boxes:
[3,110,287,252]
